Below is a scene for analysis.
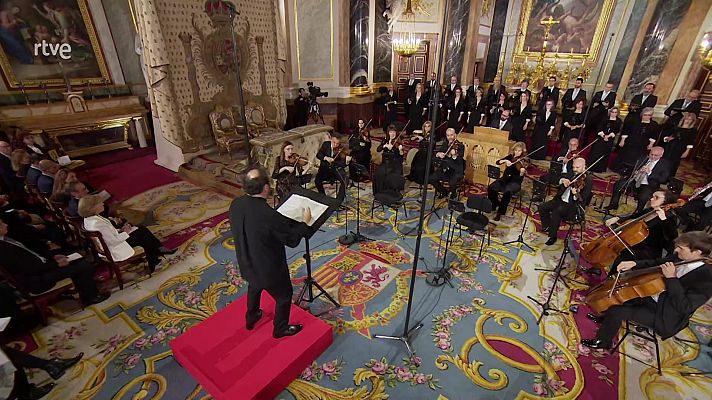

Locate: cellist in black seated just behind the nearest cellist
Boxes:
[605,190,677,275]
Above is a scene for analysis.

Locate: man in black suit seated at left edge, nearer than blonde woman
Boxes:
[0,219,109,306]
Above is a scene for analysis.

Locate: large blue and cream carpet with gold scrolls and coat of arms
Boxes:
[9,163,712,400]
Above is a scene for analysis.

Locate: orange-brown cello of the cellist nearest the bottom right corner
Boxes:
[586,258,710,314]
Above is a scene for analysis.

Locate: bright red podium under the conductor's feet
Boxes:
[170,292,333,400]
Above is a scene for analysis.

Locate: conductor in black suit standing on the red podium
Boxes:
[230,168,312,338]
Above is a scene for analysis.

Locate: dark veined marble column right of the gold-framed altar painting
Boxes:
[623,0,692,102]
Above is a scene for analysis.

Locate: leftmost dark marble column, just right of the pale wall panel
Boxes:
[349,0,369,86]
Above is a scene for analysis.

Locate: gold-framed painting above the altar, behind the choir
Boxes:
[515,0,614,59]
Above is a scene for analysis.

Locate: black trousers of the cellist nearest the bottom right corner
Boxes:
[596,297,657,344]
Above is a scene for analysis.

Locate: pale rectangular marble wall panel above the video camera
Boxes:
[294,0,334,80]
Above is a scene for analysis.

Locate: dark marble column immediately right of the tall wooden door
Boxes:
[443,0,470,82]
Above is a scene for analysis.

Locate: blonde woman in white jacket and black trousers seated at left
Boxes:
[79,194,175,272]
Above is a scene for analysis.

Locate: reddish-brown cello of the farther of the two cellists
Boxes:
[582,200,685,269]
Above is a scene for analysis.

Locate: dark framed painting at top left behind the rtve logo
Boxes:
[0,0,110,90]
